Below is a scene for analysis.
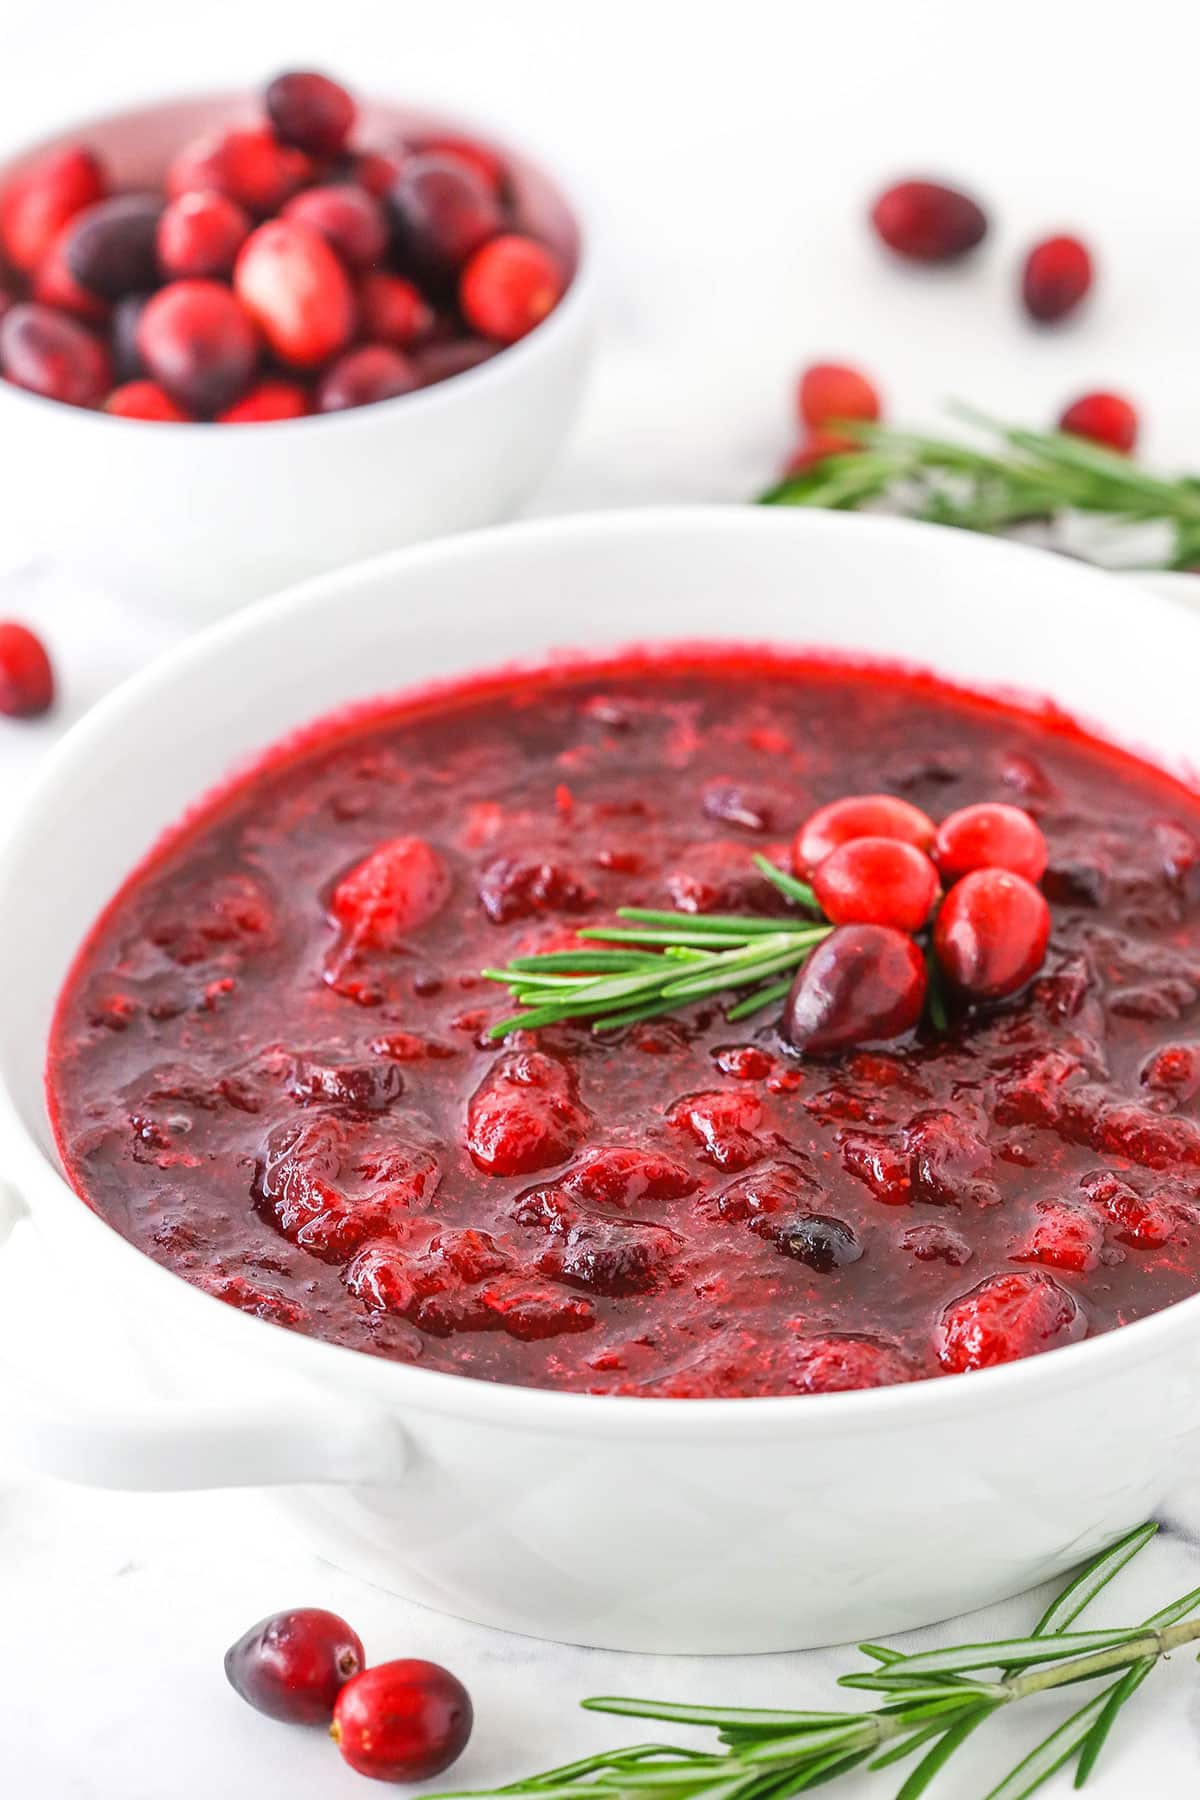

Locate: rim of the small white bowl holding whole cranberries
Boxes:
[0,88,597,437]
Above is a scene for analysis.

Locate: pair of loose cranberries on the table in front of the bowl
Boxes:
[225,1607,473,1782]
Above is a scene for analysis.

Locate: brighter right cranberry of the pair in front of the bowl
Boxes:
[331,1661,473,1782]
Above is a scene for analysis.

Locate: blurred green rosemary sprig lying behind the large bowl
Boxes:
[759,409,1200,569]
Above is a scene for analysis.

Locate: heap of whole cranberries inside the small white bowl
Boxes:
[0,72,567,425]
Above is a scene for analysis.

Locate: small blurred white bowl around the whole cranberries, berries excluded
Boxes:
[0,94,592,617]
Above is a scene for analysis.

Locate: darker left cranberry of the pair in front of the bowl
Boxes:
[225,1606,367,1724]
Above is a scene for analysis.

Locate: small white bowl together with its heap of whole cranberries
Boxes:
[0,72,590,612]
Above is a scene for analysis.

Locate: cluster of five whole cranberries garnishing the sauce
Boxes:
[783,794,1051,1055]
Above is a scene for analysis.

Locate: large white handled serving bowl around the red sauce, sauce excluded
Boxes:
[0,508,1200,1652]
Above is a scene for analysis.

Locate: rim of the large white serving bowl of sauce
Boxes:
[9,504,1200,1442]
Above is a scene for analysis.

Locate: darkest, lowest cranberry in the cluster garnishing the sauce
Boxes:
[783,925,927,1055]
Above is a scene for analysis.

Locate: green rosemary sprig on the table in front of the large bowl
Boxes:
[435,1525,1200,1800]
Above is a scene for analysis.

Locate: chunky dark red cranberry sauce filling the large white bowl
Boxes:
[49,653,1200,1397]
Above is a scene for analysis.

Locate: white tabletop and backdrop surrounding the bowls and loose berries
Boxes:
[0,0,1200,1800]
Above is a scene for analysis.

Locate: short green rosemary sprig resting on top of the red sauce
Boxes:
[482,857,833,1039]
